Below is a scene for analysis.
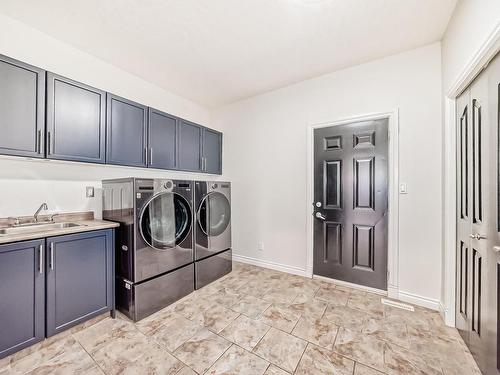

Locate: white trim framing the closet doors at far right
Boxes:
[440,25,500,327]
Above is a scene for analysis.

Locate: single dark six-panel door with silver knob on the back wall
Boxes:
[313,119,388,290]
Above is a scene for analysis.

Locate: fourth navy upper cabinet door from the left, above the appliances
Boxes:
[148,108,177,169]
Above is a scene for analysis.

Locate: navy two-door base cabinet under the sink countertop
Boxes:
[0,229,114,358]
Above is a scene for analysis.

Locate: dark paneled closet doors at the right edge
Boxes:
[455,51,500,374]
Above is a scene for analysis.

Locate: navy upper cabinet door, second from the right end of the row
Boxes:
[179,120,202,172]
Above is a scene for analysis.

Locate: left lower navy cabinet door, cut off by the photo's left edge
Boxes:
[0,240,45,358]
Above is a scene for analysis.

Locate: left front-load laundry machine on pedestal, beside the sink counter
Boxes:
[103,178,194,321]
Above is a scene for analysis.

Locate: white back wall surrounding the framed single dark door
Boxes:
[212,43,442,301]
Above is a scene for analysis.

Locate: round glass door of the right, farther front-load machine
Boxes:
[198,192,231,236]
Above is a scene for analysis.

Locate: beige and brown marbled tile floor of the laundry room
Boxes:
[0,263,479,375]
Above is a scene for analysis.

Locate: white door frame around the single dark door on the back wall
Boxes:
[306,108,399,298]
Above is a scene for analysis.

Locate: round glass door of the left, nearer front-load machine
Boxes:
[140,193,191,250]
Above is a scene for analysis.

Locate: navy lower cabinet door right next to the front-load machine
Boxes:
[46,230,114,337]
